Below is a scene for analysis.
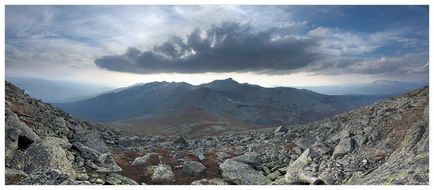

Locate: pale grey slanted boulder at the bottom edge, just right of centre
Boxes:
[220,159,271,185]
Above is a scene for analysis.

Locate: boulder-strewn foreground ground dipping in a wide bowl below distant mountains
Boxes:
[5,83,429,185]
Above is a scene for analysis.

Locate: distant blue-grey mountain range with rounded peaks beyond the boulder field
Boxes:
[56,79,384,134]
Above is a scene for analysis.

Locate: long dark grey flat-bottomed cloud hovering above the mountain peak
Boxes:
[95,23,322,73]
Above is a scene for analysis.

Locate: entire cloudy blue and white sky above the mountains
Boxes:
[5,5,429,87]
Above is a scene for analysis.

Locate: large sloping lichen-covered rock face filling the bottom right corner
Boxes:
[348,106,429,185]
